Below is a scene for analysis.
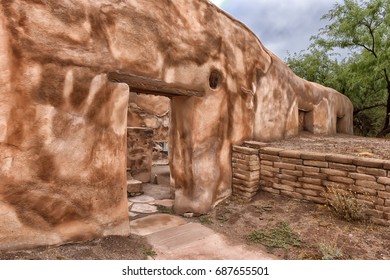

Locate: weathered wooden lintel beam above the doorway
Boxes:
[108,72,204,97]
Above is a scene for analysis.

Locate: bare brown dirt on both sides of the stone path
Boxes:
[0,192,390,260]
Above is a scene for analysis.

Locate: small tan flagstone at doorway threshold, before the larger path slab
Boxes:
[130,214,187,236]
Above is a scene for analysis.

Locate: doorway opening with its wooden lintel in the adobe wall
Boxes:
[108,73,204,212]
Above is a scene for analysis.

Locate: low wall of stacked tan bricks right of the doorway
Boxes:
[232,142,390,226]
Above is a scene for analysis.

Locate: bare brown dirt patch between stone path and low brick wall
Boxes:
[189,192,390,260]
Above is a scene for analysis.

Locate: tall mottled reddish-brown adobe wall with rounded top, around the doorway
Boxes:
[0,0,352,248]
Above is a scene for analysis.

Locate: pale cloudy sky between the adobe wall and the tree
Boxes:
[210,0,340,59]
